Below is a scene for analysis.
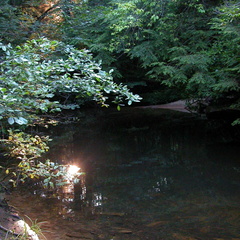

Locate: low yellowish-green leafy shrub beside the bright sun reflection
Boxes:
[4,131,83,188]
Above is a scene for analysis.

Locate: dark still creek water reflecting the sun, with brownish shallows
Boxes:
[7,108,240,240]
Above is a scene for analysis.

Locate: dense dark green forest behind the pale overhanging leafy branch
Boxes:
[0,0,240,115]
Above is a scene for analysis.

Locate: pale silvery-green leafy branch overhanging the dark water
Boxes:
[0,38,140,128]
